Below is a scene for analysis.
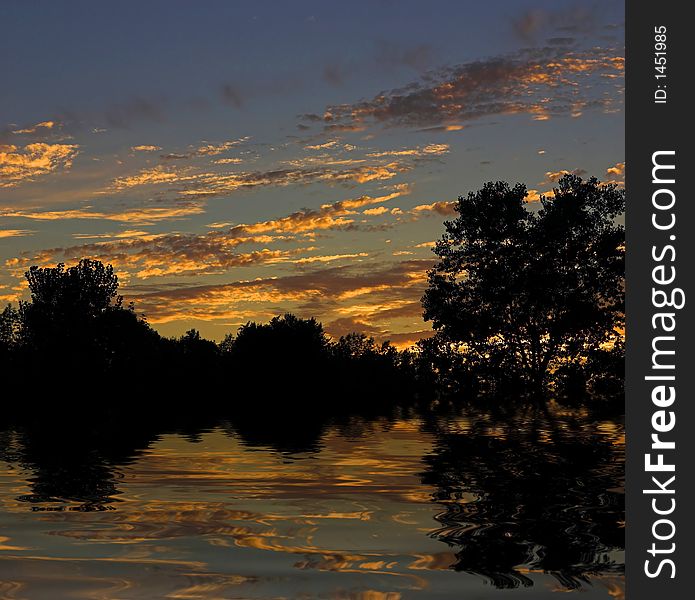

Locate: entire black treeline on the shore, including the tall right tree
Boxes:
[0,174,625,412]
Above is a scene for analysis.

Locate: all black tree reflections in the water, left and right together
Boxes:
[0,406,624,589]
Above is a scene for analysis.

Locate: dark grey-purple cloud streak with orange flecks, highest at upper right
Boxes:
[304,47,624,130]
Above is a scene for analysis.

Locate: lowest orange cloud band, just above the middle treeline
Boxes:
[124,255,432,328]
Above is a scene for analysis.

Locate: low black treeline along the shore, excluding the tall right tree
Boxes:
[0,259,622,414]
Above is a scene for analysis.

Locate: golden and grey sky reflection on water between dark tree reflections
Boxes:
[0,421,623,600]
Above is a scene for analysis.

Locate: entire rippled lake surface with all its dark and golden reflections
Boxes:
[0,409,624,600]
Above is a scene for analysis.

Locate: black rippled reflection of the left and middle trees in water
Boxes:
[0,390,406,511]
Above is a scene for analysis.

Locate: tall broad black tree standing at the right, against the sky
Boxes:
[423,175,625,386]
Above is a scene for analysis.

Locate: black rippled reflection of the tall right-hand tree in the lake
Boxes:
[422,410,624,589]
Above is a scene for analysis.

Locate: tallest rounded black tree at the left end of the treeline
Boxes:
[19,259,159,384]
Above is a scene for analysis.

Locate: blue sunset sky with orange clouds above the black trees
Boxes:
[0,0,625,346]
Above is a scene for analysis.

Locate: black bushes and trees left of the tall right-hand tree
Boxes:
[0,259,422,420]
